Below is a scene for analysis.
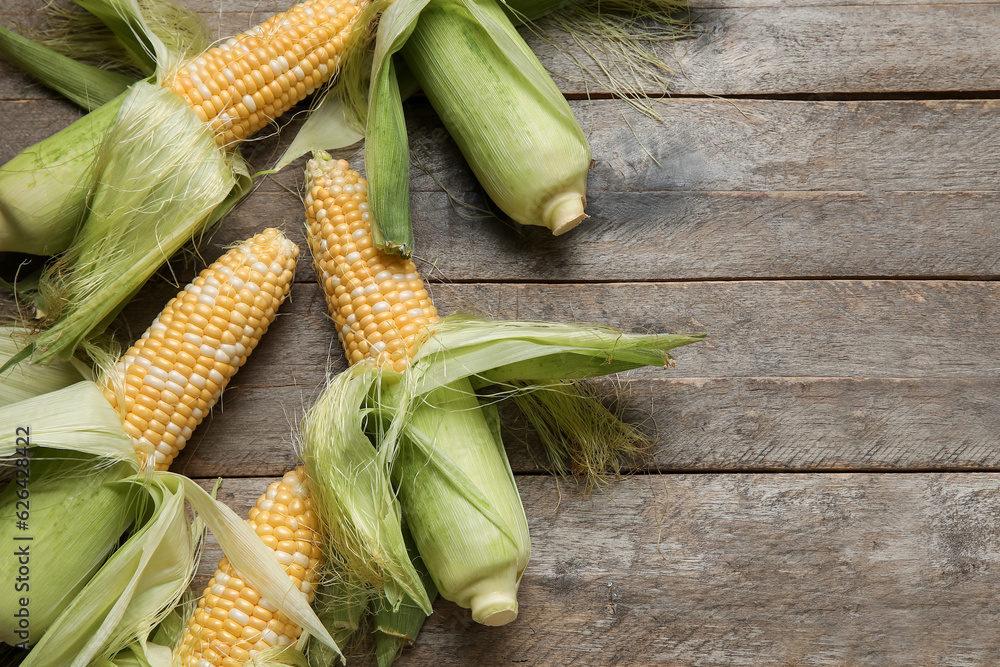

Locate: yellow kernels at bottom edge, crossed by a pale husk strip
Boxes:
[177,468,322,667]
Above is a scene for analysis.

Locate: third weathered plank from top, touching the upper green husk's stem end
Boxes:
[216,190,1000,282]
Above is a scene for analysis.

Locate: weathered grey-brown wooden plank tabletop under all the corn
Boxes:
[0,0,1000,666]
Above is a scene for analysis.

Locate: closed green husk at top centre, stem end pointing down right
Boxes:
[398,0,591,235]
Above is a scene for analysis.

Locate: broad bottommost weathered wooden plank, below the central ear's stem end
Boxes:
[198,474,1000,667]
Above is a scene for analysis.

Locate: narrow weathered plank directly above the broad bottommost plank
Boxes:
[172,377,1000,477]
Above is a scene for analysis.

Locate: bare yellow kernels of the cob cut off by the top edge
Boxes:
[164,0,363,146]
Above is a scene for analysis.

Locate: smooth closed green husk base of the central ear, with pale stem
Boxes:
[392,378,531,625]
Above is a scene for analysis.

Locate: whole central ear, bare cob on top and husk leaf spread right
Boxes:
[302,154,700,640]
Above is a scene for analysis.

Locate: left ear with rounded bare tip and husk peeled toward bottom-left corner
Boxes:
[0,230,344,667]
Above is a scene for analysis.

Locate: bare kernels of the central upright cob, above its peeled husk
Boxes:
[305,159,437,372]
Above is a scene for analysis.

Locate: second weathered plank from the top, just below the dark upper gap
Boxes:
[11,99,1000,197]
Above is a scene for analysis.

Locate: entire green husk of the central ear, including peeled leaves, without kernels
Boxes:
[301,317,701,636]
